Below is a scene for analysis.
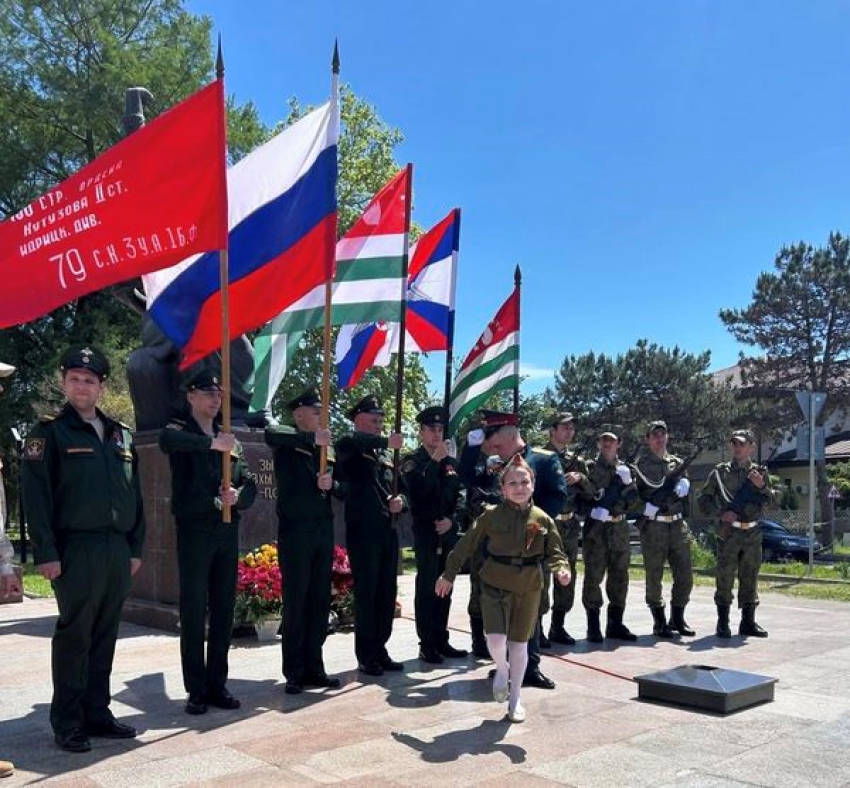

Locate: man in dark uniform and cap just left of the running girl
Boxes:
[401,405,468,665]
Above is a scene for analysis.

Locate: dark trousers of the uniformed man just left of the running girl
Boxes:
[413,524,452,650]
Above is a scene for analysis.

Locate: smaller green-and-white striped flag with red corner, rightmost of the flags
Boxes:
[446,288,519,435]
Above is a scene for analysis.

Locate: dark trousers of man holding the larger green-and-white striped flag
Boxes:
[346,521,398,665]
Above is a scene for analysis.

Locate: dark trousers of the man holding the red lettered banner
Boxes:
[177,522,239,695]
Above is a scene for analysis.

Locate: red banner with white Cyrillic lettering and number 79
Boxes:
[0,80,227,328]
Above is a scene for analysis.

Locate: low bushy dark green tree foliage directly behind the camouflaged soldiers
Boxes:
[546,339,736,455]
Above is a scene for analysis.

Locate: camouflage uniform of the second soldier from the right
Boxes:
[634,451,694,637]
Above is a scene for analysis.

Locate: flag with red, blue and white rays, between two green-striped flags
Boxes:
[336,208,460,388]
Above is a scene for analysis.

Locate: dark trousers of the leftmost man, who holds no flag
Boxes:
[50,531,130,733]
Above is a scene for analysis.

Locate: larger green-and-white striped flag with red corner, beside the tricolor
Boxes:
[251,168,409,411]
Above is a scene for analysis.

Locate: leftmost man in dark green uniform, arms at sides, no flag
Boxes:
[21,346,145,752]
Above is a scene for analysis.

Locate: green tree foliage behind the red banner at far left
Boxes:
[0,0,267,448]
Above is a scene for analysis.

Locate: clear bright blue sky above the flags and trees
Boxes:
[188,0,850,394]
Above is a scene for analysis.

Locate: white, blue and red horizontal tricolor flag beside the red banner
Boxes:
[145,101,339,368]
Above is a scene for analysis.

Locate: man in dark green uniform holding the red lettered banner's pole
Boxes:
[159,369,257,714]
